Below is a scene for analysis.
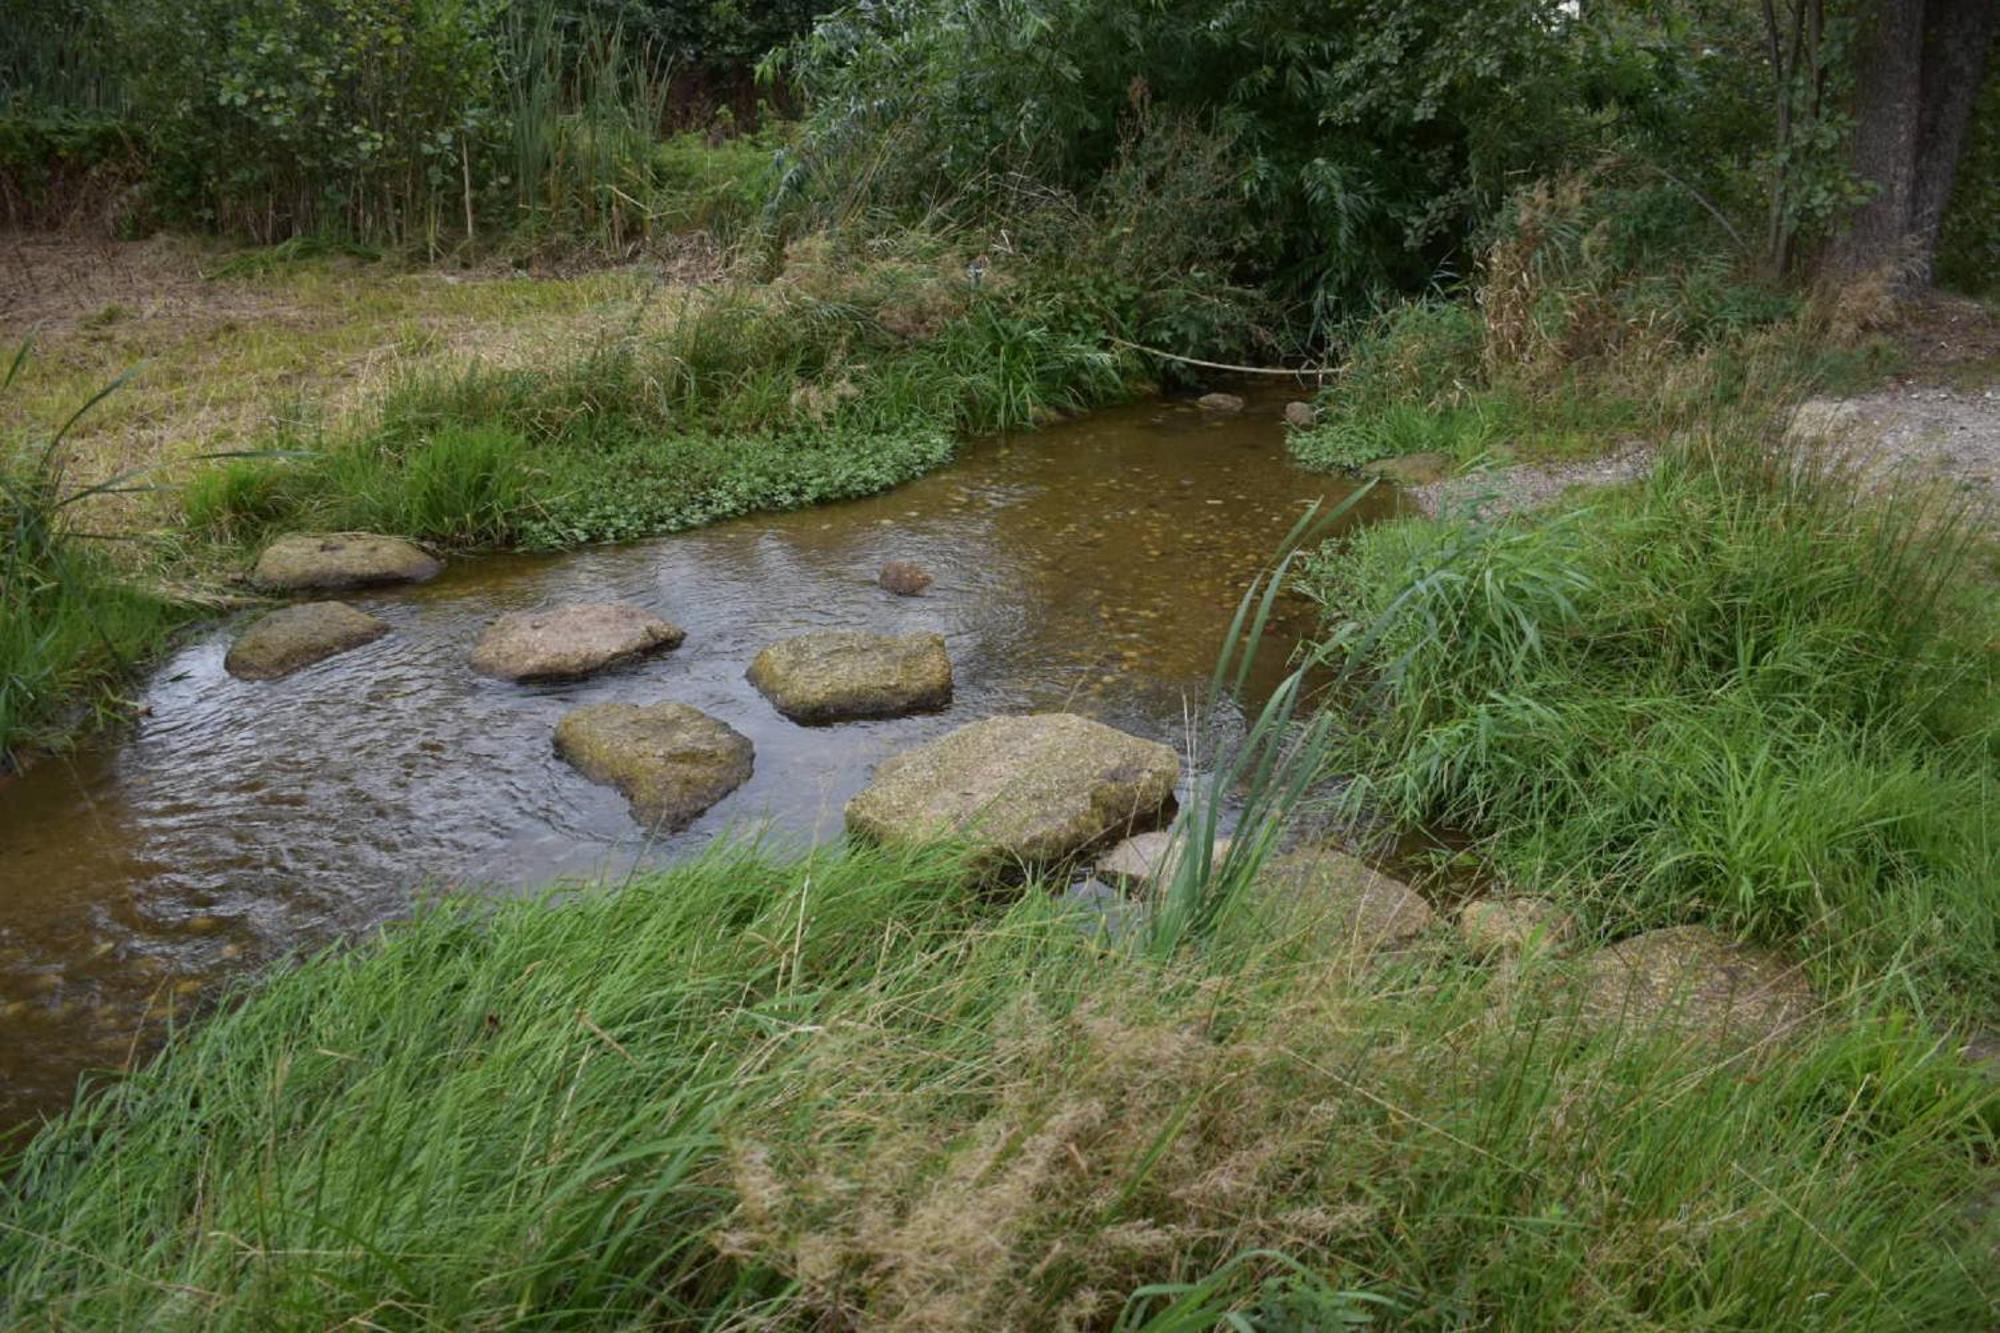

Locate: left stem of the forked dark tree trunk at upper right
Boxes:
[1826,0,1920,276]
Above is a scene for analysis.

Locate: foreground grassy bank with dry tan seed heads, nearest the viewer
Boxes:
[0,836,1994,1329]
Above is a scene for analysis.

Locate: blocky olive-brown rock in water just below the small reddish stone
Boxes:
[746,630,952,725]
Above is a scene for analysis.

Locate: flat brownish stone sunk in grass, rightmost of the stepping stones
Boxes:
[1582,927,1818,1043]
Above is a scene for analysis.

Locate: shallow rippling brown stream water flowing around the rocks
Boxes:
[0,400,1390,1131]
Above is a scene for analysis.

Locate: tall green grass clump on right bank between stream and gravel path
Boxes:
[1316,410,2000,1021]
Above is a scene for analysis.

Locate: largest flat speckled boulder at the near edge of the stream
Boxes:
[846,713,1180,871]
